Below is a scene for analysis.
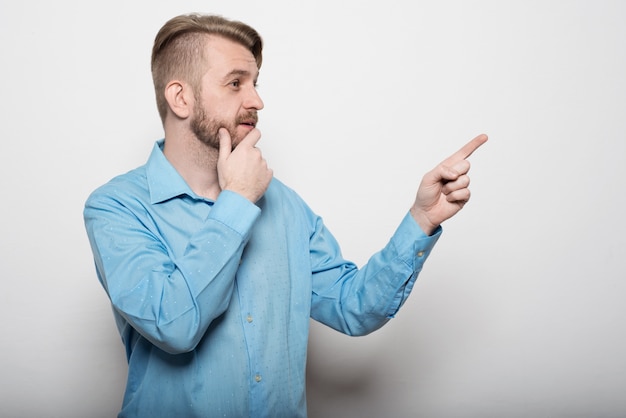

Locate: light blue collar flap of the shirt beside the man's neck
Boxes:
[146,139,194,204]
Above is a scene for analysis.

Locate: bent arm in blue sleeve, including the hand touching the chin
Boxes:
[84,130,272,353]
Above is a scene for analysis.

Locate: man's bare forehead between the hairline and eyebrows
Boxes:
[205,36,259,77]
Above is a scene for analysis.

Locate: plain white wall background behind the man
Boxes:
[0,0,626,418]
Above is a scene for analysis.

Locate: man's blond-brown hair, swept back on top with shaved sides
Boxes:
[151,14,263,122]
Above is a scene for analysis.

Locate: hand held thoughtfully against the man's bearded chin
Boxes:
[217,128,273,203]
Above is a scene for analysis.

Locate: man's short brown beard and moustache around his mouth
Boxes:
[190,104,258,150]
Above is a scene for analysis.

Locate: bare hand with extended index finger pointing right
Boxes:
[411,134,487,235]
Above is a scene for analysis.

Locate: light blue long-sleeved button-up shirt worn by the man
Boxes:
[84,141,441,418]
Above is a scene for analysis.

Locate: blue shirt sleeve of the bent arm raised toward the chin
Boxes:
[84,191,260,353]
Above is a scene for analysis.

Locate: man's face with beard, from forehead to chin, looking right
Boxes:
[190,36,263,149]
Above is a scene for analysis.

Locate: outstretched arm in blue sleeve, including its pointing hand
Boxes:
[311,135,487,335]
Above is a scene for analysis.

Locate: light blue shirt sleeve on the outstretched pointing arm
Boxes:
[310,213,442,335]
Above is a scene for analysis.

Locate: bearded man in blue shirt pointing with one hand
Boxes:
[84,11,487,418]
